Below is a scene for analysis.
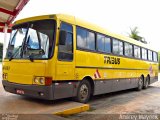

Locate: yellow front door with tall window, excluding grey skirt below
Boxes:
[56,22,74,80]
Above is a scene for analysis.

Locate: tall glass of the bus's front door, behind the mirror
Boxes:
[58,22,73,61]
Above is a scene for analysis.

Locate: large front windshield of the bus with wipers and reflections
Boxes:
[5,20,55,60]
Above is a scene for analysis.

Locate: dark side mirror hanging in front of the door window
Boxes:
[59,30,67,45]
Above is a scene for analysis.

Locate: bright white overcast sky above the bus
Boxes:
[0,0,160,51]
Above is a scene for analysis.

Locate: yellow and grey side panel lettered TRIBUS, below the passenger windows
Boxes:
[75,50,157,95]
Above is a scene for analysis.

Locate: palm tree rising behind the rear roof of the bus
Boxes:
[129,27,147,44]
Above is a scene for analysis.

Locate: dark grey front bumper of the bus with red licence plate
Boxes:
[2,80,53,100]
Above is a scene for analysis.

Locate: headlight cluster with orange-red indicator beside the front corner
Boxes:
[33,76,52,86]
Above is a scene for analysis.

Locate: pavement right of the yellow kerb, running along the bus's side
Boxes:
[68,81,160,120]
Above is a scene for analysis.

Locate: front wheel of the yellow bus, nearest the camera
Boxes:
[75,79,91,103]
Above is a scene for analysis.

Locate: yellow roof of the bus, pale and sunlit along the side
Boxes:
[14,14,155,51]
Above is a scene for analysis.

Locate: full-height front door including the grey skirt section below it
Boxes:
[54,22,74,99]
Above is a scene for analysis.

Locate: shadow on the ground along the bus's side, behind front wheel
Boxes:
[89,86,159,106]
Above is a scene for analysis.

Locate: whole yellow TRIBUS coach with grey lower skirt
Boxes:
[2,14,158,103]
